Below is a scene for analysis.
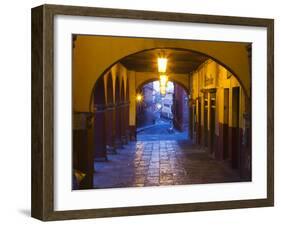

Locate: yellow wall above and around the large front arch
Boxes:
[73,35,250,112]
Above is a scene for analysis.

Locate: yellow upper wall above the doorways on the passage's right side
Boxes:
[191,59,247,134]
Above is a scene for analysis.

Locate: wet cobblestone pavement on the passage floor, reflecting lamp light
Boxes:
[94,140,240,188]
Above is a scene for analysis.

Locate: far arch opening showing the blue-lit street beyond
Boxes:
[136,80,190,141]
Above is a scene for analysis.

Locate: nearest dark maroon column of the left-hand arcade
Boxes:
[94,105,107,161]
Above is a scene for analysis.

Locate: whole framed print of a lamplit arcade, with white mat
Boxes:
[32,5,274,221]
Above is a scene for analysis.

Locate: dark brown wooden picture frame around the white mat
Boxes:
[31,5,274,221]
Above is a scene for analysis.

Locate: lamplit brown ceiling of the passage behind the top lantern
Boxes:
[121,49,208,74]
